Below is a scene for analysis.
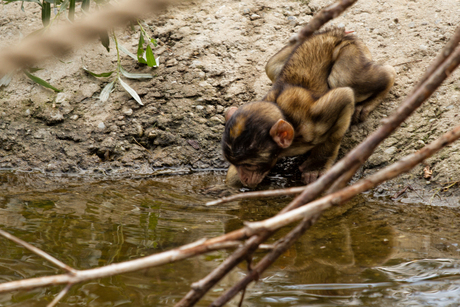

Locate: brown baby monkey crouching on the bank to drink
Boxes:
[222,29,396,188]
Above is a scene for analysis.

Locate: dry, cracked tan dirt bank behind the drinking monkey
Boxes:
[0,0,460,194]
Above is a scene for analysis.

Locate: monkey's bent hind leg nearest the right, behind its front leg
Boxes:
[328,42,396,123]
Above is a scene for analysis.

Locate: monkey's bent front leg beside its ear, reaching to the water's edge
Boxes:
[299,87,354,184]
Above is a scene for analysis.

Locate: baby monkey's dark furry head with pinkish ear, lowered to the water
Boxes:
[222,101,294,188]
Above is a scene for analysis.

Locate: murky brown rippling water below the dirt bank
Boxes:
[0,172,460,306]
